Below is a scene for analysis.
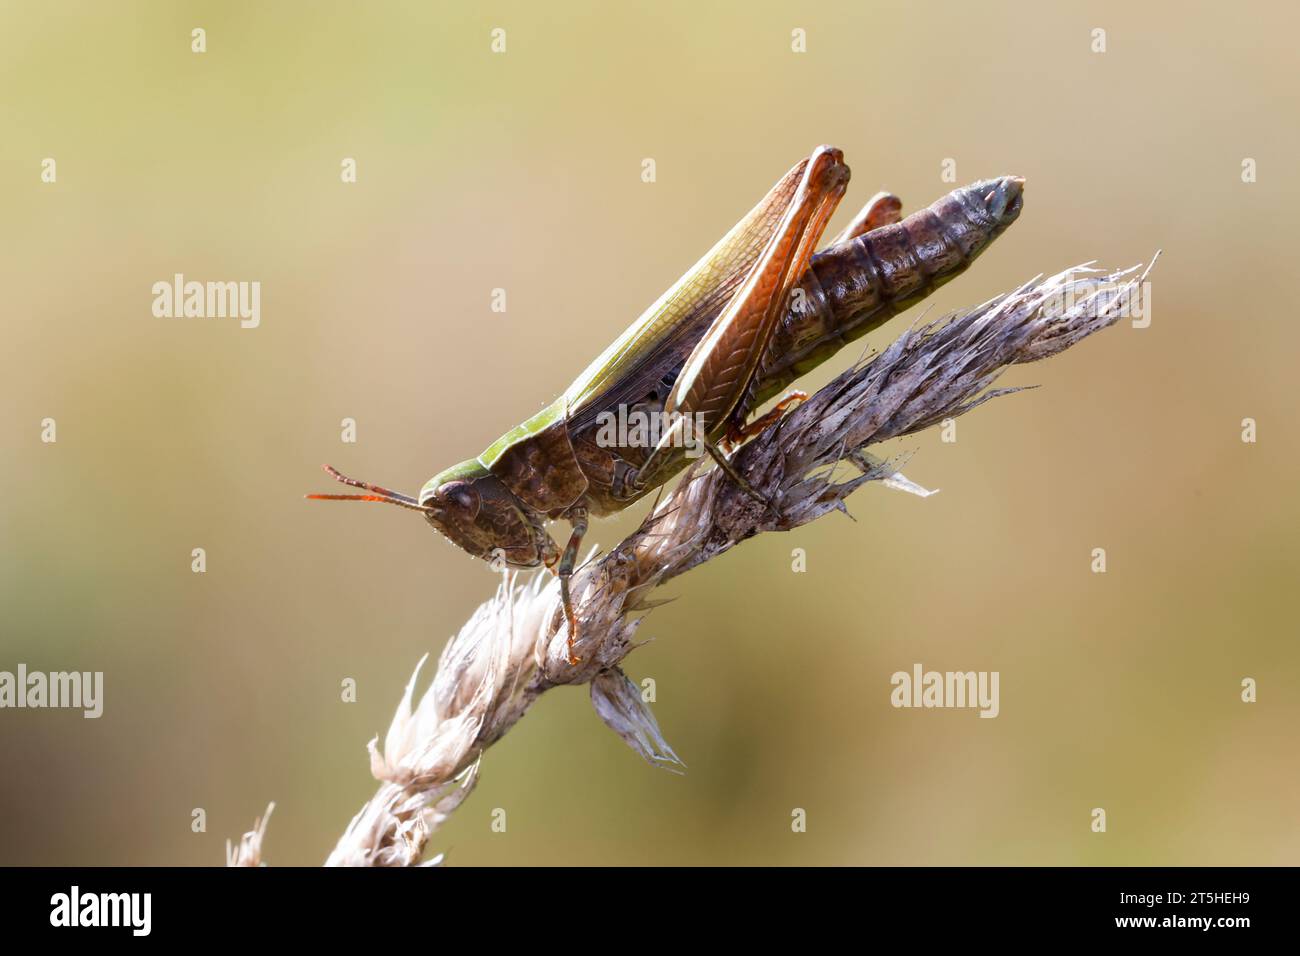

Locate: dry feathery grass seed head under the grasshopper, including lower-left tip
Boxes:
[231,257,1149,866]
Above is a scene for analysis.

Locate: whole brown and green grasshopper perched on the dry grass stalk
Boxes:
[307,146,1024,665]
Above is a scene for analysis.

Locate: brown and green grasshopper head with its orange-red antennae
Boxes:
[307,459,559,567]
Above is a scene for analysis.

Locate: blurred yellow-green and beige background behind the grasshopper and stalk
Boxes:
[0,1,1300,865]
